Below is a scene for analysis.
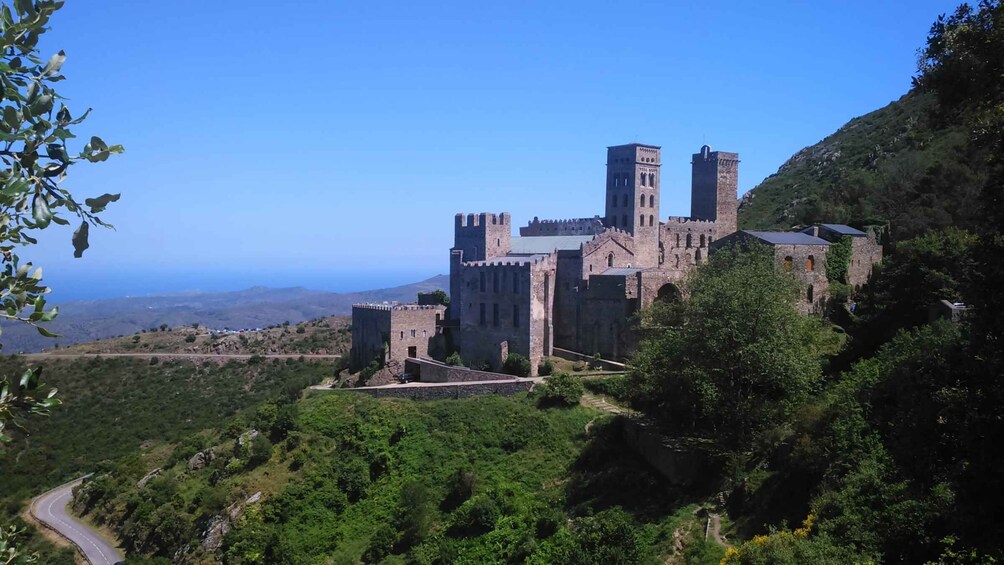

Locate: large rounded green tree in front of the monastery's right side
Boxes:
[630,245,829,449]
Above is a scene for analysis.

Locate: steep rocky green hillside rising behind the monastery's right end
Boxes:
[739,92,987,240]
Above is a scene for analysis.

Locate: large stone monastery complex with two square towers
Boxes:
[351,144,882,371]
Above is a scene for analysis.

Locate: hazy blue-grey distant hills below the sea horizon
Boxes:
[0,275,450,353]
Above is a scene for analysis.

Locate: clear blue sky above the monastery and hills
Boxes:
[30,0,958,299]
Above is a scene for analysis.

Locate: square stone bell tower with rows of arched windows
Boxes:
[603,144,662,268]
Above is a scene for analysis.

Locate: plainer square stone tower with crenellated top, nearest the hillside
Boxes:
[691,146,739,239]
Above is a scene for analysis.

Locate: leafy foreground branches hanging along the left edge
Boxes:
[0,0,122,563]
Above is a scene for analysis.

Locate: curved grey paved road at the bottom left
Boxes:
[30,479,126,565]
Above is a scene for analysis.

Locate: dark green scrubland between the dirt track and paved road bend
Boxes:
[0,356,332,561]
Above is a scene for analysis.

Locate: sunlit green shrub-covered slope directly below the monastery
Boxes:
[77,391,721,564]
